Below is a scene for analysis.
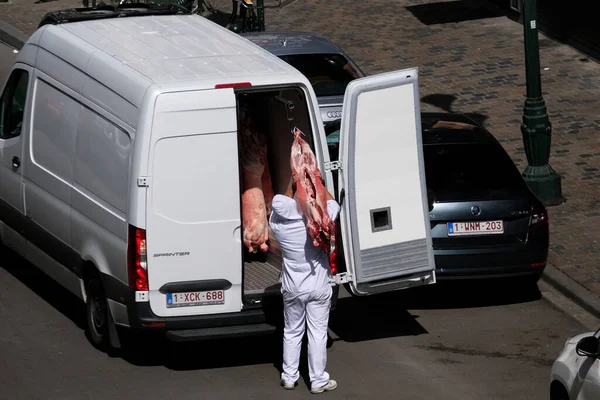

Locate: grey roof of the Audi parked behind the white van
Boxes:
[241,32,344,56]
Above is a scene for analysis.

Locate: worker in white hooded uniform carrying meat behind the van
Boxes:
[269,177,340,394]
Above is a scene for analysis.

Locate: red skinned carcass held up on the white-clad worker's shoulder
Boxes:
[290,128,334,252]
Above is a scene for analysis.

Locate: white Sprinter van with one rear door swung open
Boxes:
[0,15,435,347]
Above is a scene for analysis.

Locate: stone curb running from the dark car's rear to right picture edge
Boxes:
[542,264,600,318]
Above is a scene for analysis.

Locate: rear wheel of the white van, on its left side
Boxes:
[85,278,109,350]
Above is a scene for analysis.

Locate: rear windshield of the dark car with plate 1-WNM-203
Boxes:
[424,143,527,201]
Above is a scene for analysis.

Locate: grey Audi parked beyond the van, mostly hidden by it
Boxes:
[242,32,365,123]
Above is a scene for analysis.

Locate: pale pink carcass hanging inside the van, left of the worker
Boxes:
[239,119,273,253]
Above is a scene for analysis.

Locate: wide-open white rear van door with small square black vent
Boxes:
[335,68,436,296]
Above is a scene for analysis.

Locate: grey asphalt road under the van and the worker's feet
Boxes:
[0,45,589,400]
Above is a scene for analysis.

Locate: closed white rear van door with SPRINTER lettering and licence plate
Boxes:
[146,89,242,316]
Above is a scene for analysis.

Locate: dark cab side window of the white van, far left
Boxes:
[0,69,29,140]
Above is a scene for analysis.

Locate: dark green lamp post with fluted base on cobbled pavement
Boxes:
[521,0,564,205]
